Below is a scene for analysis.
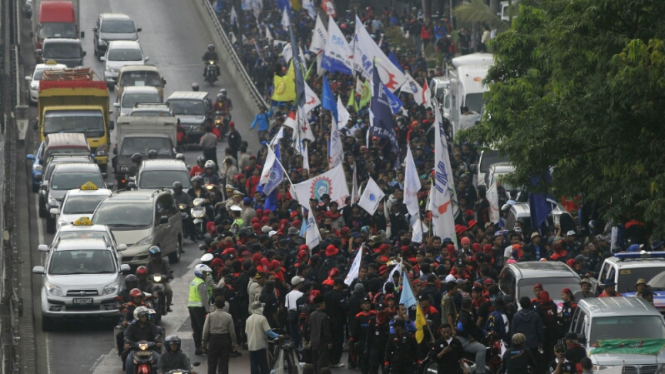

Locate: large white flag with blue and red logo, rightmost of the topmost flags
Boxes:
[353,16,406,92]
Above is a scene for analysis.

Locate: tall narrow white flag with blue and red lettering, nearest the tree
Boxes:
[431,104,459,238]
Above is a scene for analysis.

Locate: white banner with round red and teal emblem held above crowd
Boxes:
[293,165,349,208]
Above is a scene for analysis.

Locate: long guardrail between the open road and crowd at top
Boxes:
[193,0,270,112]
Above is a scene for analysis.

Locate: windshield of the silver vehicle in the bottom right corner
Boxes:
[588,315,665,346]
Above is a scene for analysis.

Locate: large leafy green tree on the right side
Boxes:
[462,0,665,235]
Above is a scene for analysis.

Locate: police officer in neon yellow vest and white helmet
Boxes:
[187,264,212,356]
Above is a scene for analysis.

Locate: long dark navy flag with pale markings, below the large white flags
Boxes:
[368,62,401,162]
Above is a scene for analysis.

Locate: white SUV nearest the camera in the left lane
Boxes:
[32,239,130,331]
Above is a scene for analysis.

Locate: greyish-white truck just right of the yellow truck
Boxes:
[112,117,178,189]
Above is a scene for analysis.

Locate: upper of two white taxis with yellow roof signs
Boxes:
[56,182,113,229]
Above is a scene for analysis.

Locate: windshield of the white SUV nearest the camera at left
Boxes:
[48,250,116,275]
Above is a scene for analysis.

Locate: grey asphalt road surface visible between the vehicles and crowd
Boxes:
[19,0,258,374]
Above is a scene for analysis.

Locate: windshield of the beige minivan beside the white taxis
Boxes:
[92,202,153,228]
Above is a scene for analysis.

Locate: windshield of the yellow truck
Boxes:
[44,110,104,138]
